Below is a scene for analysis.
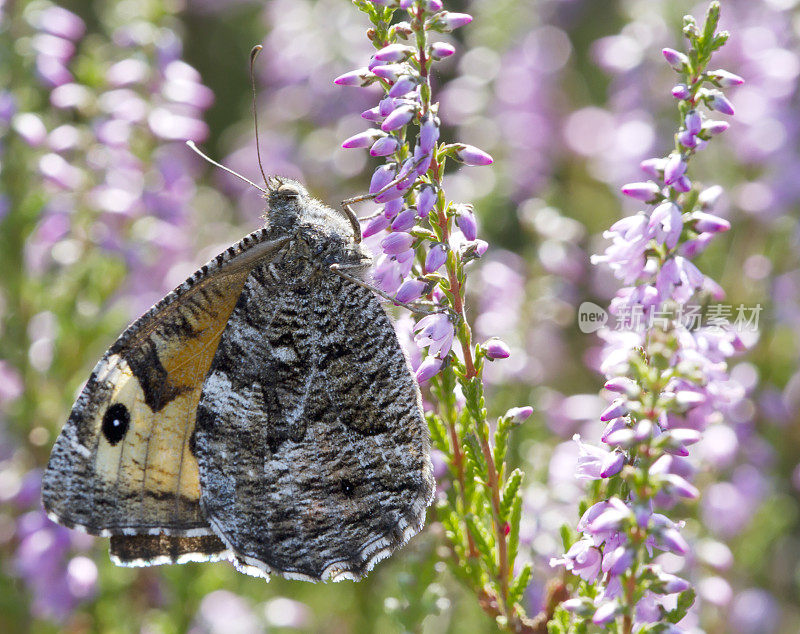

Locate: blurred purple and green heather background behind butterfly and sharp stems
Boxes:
[0,0,800,634]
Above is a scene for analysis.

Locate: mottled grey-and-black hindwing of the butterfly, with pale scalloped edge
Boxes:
[195,265,434,580]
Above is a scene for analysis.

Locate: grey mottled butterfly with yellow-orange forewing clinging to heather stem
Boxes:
[42,178,434,581]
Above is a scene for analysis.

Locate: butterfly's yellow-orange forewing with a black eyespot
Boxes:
[42,230,285,544]
